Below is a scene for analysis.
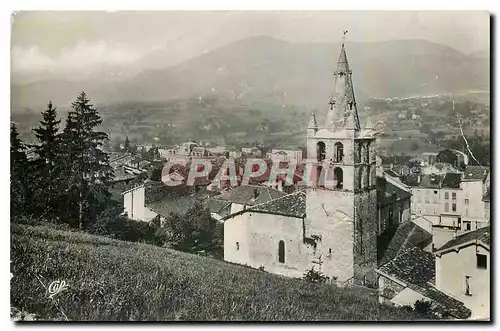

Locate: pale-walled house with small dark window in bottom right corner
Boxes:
[434,226,491,318]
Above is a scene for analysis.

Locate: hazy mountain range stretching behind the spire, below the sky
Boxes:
[11,36,489,109]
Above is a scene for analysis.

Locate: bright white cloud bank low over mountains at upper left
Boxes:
[11,40,144,75]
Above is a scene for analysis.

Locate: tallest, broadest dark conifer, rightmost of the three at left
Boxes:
[63,92,114,229]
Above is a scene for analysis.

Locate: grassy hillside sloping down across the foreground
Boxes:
[11,225,426,321]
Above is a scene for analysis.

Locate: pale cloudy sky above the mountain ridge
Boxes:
[11,10,490,77]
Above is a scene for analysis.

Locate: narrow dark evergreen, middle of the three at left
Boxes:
[33,102,61,216]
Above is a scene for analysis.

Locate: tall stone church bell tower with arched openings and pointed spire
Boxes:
[306,31,377,283]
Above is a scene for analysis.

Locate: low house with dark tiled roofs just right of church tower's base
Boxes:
[375,246,471,319]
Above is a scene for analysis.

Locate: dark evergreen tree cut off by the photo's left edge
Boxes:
[10,123,30,220]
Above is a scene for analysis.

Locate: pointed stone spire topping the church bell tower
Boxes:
[326,31,361,132]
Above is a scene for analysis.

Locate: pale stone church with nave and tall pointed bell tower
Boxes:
[224,38,380,285]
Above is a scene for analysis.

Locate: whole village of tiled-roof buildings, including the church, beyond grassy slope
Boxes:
[102,39,491,319]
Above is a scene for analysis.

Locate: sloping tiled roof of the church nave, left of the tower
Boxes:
[247,191,306,218]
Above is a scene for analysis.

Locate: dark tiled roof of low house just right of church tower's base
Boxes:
[378,247,471,319]
